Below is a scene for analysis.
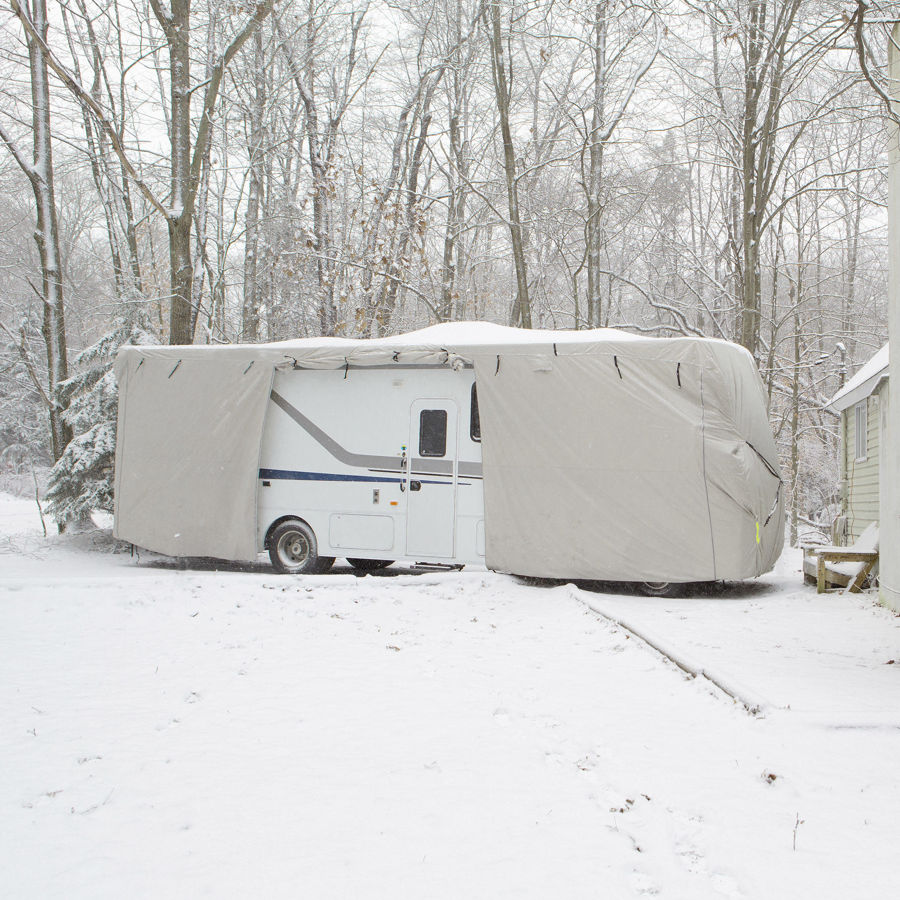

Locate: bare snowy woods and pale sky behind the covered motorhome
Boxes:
[0,0,900,538]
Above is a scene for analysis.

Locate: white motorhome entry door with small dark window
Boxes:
[406,400,458,559]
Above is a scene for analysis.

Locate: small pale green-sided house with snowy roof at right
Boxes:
[825,344,889,544]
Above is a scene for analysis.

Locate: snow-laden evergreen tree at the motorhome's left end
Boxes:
[46,318,159,527]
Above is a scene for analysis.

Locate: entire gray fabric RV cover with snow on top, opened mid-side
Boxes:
[116,323,783,581]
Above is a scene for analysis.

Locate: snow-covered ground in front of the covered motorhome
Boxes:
[0,495,900,900]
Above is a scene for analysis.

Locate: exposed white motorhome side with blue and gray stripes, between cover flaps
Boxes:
[257,366,485,565]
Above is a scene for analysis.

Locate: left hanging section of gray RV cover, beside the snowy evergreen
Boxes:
[115,347,273,560]
